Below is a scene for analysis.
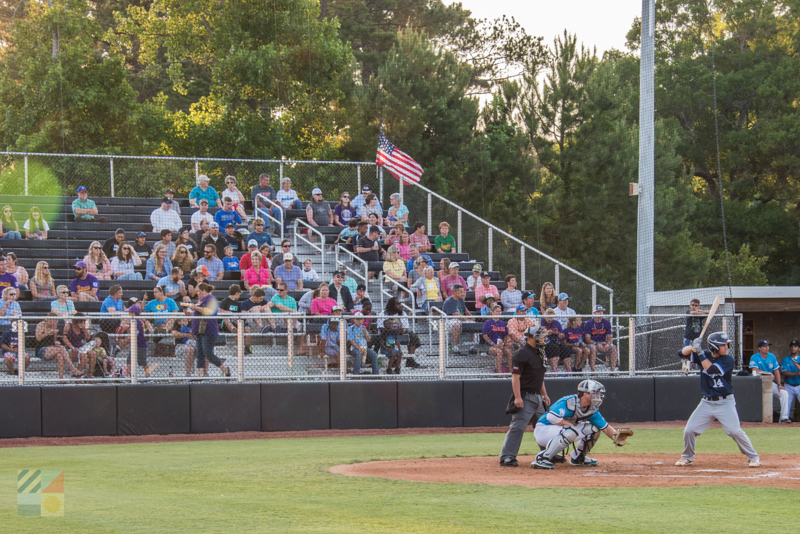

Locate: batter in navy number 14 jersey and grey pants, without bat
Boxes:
[675,332,761,467]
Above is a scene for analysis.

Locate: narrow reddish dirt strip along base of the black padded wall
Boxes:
[0,421,800,449]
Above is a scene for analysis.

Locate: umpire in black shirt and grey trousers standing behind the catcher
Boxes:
[500,326,550,467]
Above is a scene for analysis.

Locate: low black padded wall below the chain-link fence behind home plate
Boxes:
[0,376,761,438]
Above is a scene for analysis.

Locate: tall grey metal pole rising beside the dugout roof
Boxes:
[636,0,656,314]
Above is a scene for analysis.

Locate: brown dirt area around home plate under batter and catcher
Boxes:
[331,454,800,489]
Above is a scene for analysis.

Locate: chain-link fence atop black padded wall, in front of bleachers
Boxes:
[0,312,742,386]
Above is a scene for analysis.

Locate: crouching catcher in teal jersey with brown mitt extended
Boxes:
[531,380,633,469]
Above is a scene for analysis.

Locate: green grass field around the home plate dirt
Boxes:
[0,432,800,534]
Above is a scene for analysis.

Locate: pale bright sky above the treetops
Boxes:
[444,0,642,56]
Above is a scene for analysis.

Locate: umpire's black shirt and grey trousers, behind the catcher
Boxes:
[500,344,547,465]
